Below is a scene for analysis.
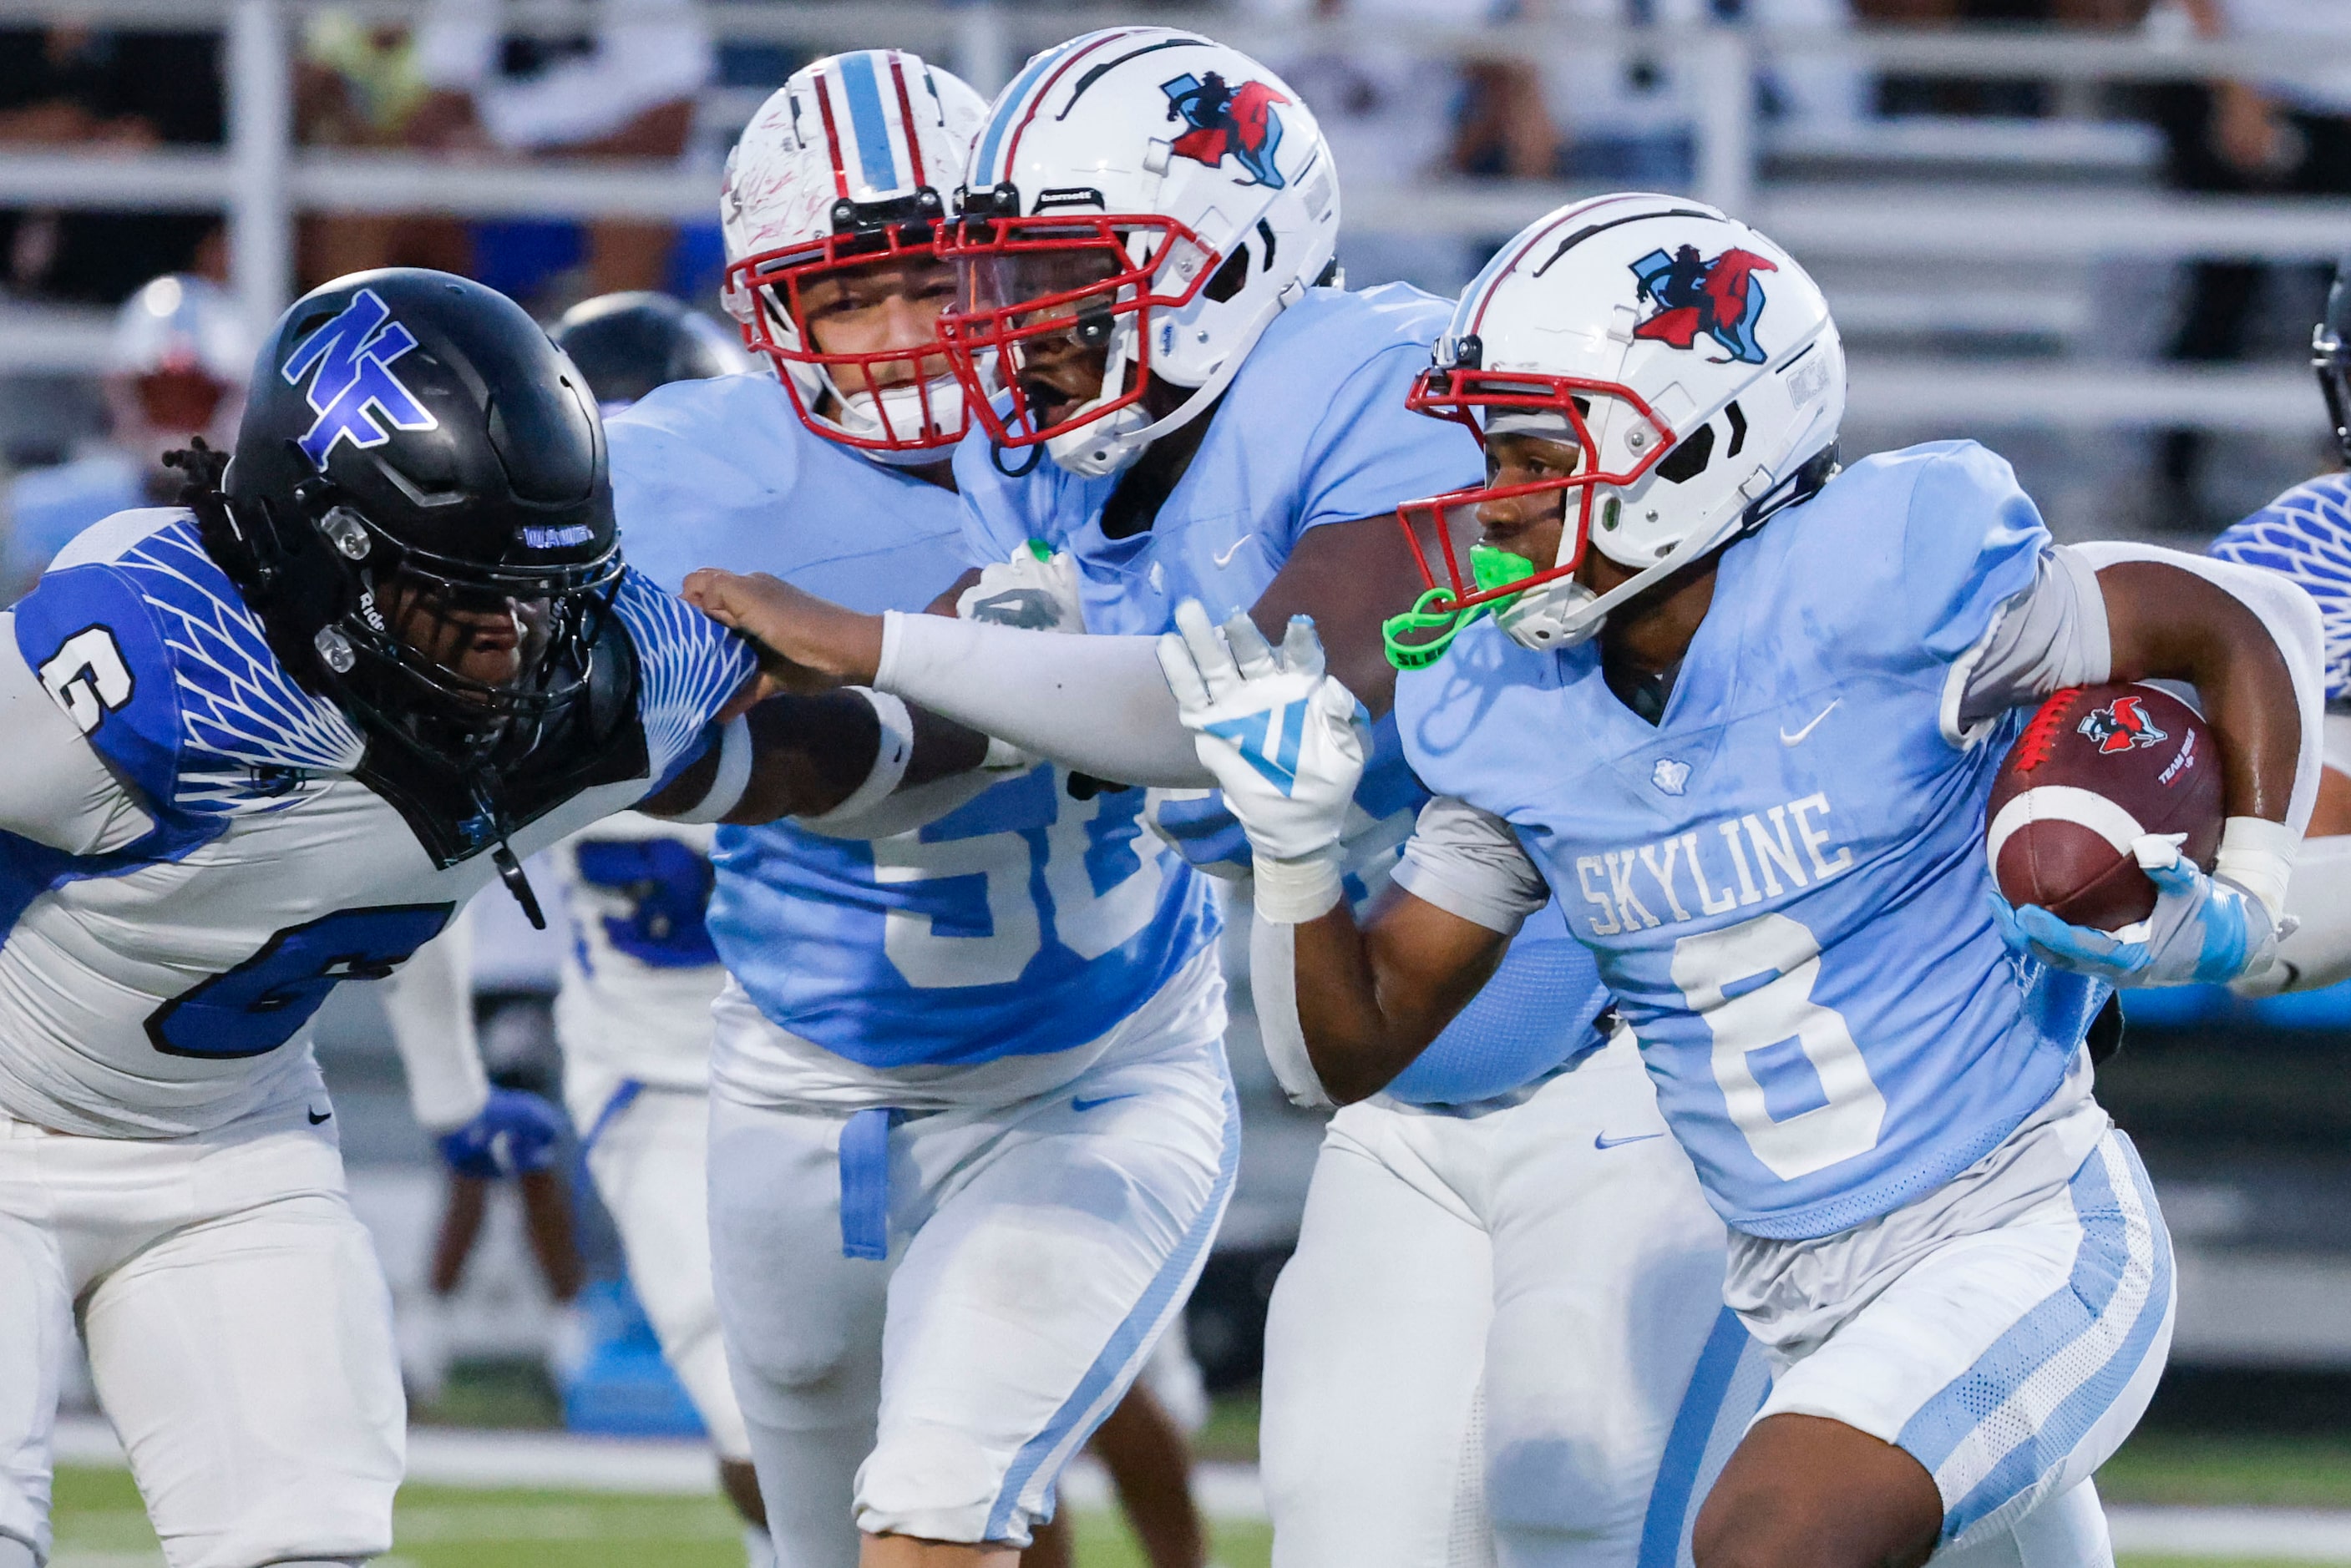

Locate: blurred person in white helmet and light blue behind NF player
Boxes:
[0,273,259,602]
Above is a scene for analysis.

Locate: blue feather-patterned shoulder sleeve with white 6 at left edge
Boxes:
[17,513,364,841]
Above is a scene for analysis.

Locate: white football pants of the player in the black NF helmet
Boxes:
[0,1077,407,1568]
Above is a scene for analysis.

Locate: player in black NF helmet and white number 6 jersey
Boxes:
[0,271,954,1568]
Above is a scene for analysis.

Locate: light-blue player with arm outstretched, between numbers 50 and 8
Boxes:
[672,28,1761,1568]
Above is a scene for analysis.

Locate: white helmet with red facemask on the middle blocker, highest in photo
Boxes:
[940,26,1338,475]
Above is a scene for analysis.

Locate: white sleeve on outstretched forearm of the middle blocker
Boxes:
[874,611,1215,790]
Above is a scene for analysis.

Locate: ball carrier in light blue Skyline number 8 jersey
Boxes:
[1162,195,2320,1568]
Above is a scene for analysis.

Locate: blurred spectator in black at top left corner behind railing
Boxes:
[0,23,225,303]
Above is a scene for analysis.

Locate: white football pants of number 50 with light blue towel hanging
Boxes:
[710,962,1241,1568]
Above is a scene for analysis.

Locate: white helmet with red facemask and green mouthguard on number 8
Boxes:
[1390,195,1846,663]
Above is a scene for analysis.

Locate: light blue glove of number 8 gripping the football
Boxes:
[1991,832,2278,989]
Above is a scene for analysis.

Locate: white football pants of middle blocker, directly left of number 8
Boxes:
[1263,1032,1763,1568]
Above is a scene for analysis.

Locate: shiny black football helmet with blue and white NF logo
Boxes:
[211,268,621,797]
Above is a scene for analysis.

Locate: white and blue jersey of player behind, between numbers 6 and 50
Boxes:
[553,811,727,1089]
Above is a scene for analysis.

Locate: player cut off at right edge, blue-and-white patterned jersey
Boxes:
[2212,255,2351,997]
